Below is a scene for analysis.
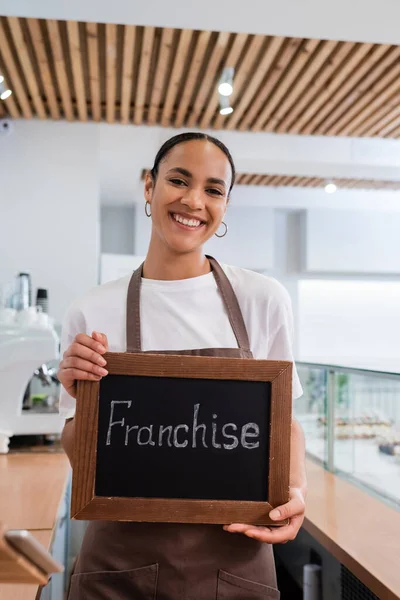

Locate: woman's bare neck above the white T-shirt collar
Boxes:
[143,244,211,281]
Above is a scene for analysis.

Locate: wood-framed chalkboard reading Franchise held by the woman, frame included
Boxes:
[71,353,292,525]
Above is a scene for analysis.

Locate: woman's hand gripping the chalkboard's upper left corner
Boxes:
[57,331,108,398]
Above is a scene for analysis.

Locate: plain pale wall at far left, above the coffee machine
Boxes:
[0,120,100,321]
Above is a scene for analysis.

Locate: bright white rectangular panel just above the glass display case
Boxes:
[298,280,400,372]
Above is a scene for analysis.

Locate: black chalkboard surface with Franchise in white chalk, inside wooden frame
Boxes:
[95,375,271,502]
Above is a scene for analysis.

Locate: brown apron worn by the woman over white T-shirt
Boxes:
[68,257,279,600]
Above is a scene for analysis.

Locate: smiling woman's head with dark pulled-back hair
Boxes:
[145,133,235,266]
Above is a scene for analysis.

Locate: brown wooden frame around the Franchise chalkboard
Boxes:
[71,353,293,526]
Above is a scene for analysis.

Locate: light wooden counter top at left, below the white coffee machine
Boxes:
[0,452,70,600]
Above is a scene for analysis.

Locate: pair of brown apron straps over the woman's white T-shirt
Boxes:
[126,256,250,352]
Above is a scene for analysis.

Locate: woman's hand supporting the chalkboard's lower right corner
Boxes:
[224,487,305,544]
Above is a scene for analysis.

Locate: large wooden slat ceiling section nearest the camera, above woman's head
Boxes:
[0,17,400,138]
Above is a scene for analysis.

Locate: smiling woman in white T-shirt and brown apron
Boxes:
[59,133,306,600]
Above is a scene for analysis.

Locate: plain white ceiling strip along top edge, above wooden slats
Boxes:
[0,0,400,44]
